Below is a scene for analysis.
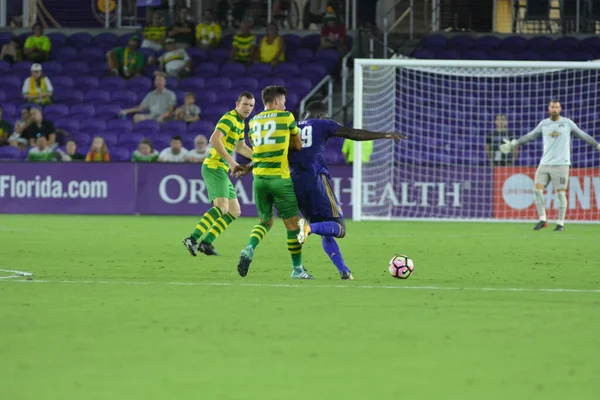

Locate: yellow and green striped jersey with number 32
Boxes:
[249,110,299,178]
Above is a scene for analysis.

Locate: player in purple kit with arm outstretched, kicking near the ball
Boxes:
[234,101,406,280]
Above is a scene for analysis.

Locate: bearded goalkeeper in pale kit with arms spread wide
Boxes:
[500,100,600,231]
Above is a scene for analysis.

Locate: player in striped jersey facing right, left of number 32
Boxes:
[183,92,254,256]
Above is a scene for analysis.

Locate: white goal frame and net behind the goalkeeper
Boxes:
[352,59,600,222]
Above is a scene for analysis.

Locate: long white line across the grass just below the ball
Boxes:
[1,280,600,294]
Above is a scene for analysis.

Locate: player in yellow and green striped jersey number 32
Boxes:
[238,86,313,279]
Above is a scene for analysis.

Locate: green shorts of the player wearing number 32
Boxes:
[254,176,298,222]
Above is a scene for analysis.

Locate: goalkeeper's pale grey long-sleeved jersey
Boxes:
[519,117,598,165]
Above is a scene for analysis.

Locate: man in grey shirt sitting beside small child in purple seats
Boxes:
[121,75,177,124]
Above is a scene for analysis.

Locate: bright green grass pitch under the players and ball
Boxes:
[0,215,600,400]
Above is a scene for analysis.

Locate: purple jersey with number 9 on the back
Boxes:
[288,119,340,175]
